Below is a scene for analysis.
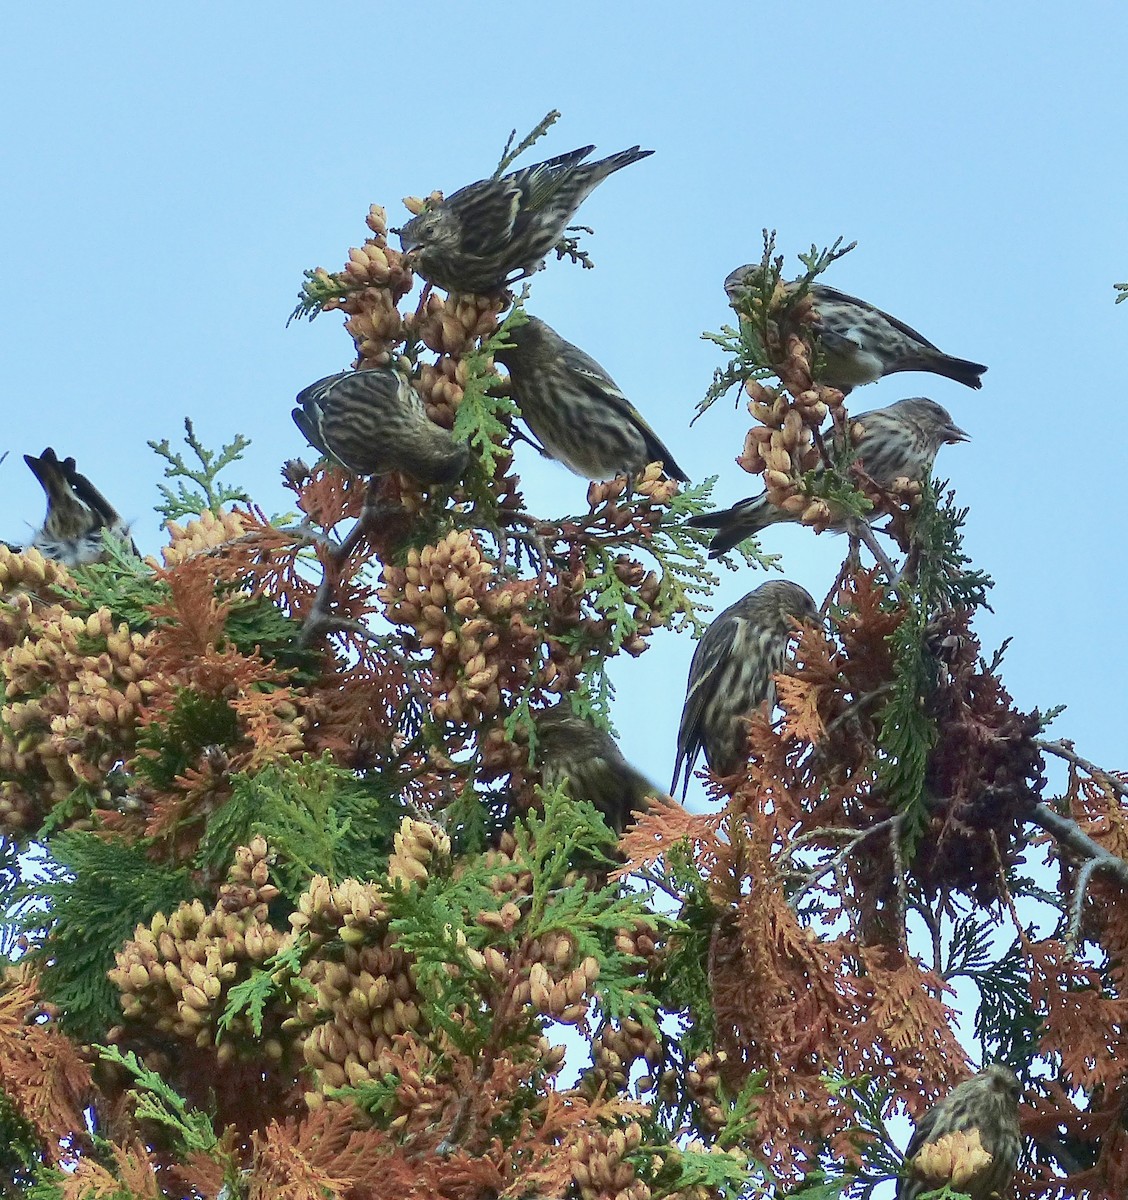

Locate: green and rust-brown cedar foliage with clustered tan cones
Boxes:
[0,120,1128,1200]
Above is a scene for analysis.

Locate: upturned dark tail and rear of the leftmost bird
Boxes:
[24,446,138,566]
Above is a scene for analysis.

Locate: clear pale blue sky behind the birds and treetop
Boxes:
[0,0,1128,806]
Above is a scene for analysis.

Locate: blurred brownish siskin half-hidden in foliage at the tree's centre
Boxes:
[536,698,662,834]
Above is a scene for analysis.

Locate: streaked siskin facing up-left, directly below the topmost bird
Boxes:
[497,317,689,482]
